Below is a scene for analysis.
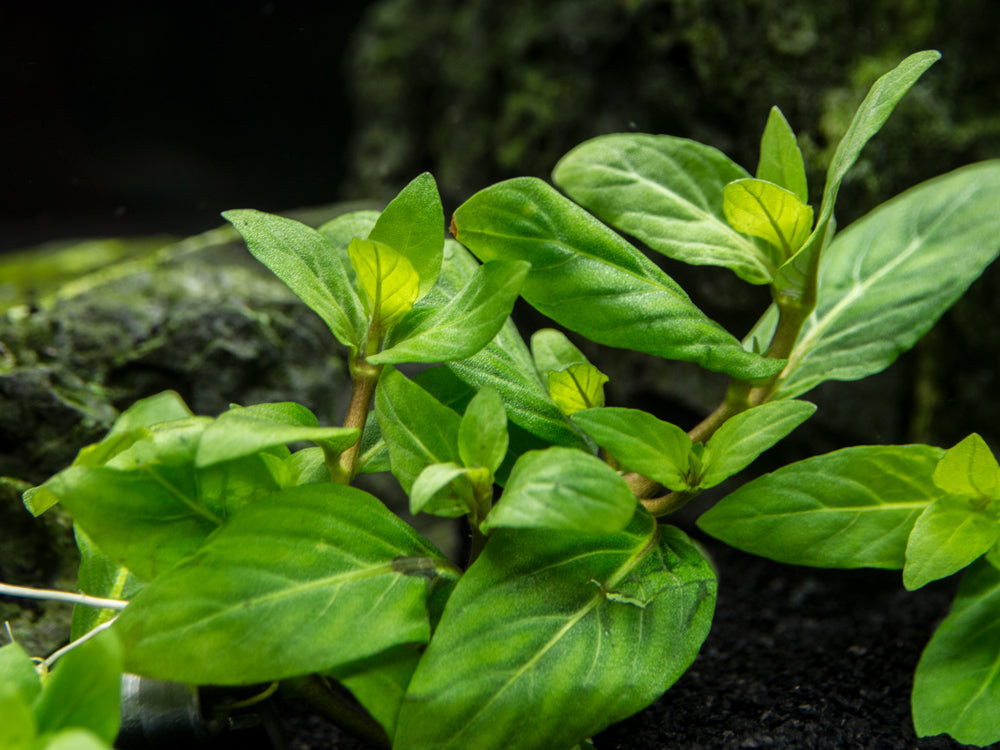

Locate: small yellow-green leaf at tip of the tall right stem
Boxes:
[722,178,812,258]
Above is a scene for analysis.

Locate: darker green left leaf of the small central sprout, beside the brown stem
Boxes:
[375,367,462,493]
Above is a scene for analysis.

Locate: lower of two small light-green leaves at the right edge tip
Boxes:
[903,495,1000,591]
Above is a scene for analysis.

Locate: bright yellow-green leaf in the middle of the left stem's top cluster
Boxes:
[347,239,420,331]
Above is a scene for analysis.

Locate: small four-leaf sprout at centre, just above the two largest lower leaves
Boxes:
[375,370,636,533]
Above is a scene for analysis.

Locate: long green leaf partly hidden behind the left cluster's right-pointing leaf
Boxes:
[438,240,584,447]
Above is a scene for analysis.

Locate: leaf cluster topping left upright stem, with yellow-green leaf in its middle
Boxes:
[223,173,527,364]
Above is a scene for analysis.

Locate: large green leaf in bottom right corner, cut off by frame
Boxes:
[913,560,1000,746]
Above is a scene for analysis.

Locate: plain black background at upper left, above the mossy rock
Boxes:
[0,0,369,250]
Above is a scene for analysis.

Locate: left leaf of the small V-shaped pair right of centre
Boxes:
[573,407,693,490]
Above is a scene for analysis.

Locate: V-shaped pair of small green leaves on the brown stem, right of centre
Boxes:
[573,401,816,490]
